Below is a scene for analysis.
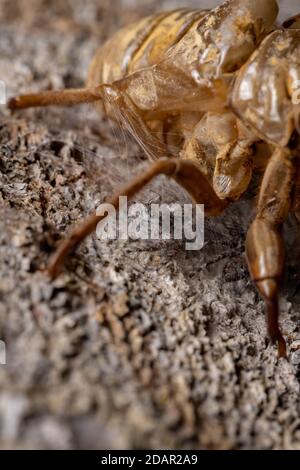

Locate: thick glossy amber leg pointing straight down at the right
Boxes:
[246,149,294,357]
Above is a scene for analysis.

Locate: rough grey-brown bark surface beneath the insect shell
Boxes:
[0,0,300,449]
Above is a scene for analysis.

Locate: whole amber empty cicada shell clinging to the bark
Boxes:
[9,0,300,357]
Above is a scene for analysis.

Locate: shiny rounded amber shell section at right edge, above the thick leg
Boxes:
[231,29,300,147]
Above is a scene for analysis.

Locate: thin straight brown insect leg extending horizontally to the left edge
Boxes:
[8,87,102,110]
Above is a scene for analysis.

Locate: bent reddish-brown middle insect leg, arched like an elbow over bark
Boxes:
[47,159,227,278]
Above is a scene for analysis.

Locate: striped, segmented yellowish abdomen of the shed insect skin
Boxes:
[87,9,207,86]
